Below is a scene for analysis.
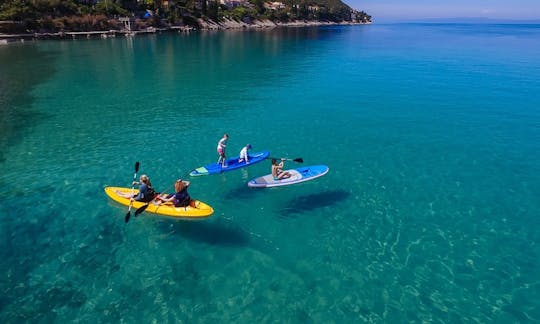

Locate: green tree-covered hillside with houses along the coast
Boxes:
[0,0,371,34]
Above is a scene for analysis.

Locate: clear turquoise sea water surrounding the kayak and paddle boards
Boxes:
[0,24,540,323]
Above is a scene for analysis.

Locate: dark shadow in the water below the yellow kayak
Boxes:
[155,222,249,246]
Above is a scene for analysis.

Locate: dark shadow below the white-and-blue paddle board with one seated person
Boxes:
[280,190,351,217]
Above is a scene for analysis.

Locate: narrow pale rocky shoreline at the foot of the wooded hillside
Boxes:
[0,19,370,45]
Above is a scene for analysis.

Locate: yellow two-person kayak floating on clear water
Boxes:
[105,187,214,219]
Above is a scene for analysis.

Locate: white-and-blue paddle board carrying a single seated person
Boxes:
[248,165,330,188]
